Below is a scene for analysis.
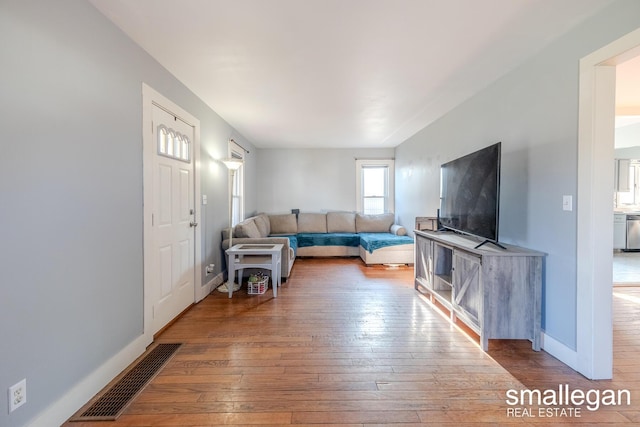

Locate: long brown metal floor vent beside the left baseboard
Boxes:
[69,344,182,421]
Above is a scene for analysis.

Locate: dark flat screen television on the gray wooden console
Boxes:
[438,142,501,247]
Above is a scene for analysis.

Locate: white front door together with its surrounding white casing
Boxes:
[143,84,202,343]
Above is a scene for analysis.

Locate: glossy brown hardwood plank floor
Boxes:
[65,258,640,427]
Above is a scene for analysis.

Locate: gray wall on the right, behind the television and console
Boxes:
[396,0,640,349]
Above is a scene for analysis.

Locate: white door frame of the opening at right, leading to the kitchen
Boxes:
[576,29,640,379]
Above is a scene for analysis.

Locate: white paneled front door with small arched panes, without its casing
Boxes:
[146,104,197,334]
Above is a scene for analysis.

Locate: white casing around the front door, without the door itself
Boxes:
[142,83,202,345]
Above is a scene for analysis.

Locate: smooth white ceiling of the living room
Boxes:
[89,0,611,148]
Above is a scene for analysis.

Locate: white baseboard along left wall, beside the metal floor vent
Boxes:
[27,335,151,427]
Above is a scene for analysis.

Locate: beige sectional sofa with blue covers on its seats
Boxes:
[222,212,413,279]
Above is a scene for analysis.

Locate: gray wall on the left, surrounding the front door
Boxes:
[0,0,255,426]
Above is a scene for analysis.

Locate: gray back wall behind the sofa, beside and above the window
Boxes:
[255,148,397,213]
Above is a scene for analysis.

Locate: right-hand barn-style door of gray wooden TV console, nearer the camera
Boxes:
[452,251,482,327]
